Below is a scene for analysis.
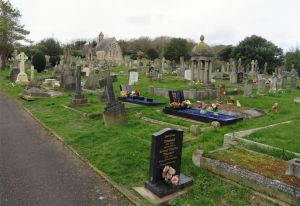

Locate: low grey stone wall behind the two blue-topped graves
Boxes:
[148,86,243,100]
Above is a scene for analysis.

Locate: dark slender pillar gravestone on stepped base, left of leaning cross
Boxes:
[71,66,87,105]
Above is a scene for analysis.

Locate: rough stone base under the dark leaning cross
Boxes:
[103,102,127,126]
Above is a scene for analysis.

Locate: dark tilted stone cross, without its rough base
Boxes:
[99,61,116,105]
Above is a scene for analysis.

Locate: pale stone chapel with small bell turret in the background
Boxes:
[90,32,123,65]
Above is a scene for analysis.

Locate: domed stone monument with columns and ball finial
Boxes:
[191,35,214,86]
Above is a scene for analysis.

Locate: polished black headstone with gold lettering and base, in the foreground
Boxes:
[145,128,193,197]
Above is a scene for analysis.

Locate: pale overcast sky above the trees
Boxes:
[10,0,300,50]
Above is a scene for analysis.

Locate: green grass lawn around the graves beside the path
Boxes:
[0,68,300,206]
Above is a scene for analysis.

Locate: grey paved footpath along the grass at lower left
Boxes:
[0,91,128,206]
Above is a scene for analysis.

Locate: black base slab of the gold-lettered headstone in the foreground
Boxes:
[145,174,193,197]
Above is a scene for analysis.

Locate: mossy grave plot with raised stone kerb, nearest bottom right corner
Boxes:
[197,147,300,206]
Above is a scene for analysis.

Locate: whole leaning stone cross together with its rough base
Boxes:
[99,61,127,126]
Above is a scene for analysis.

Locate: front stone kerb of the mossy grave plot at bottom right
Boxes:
[200,157,300,206]
